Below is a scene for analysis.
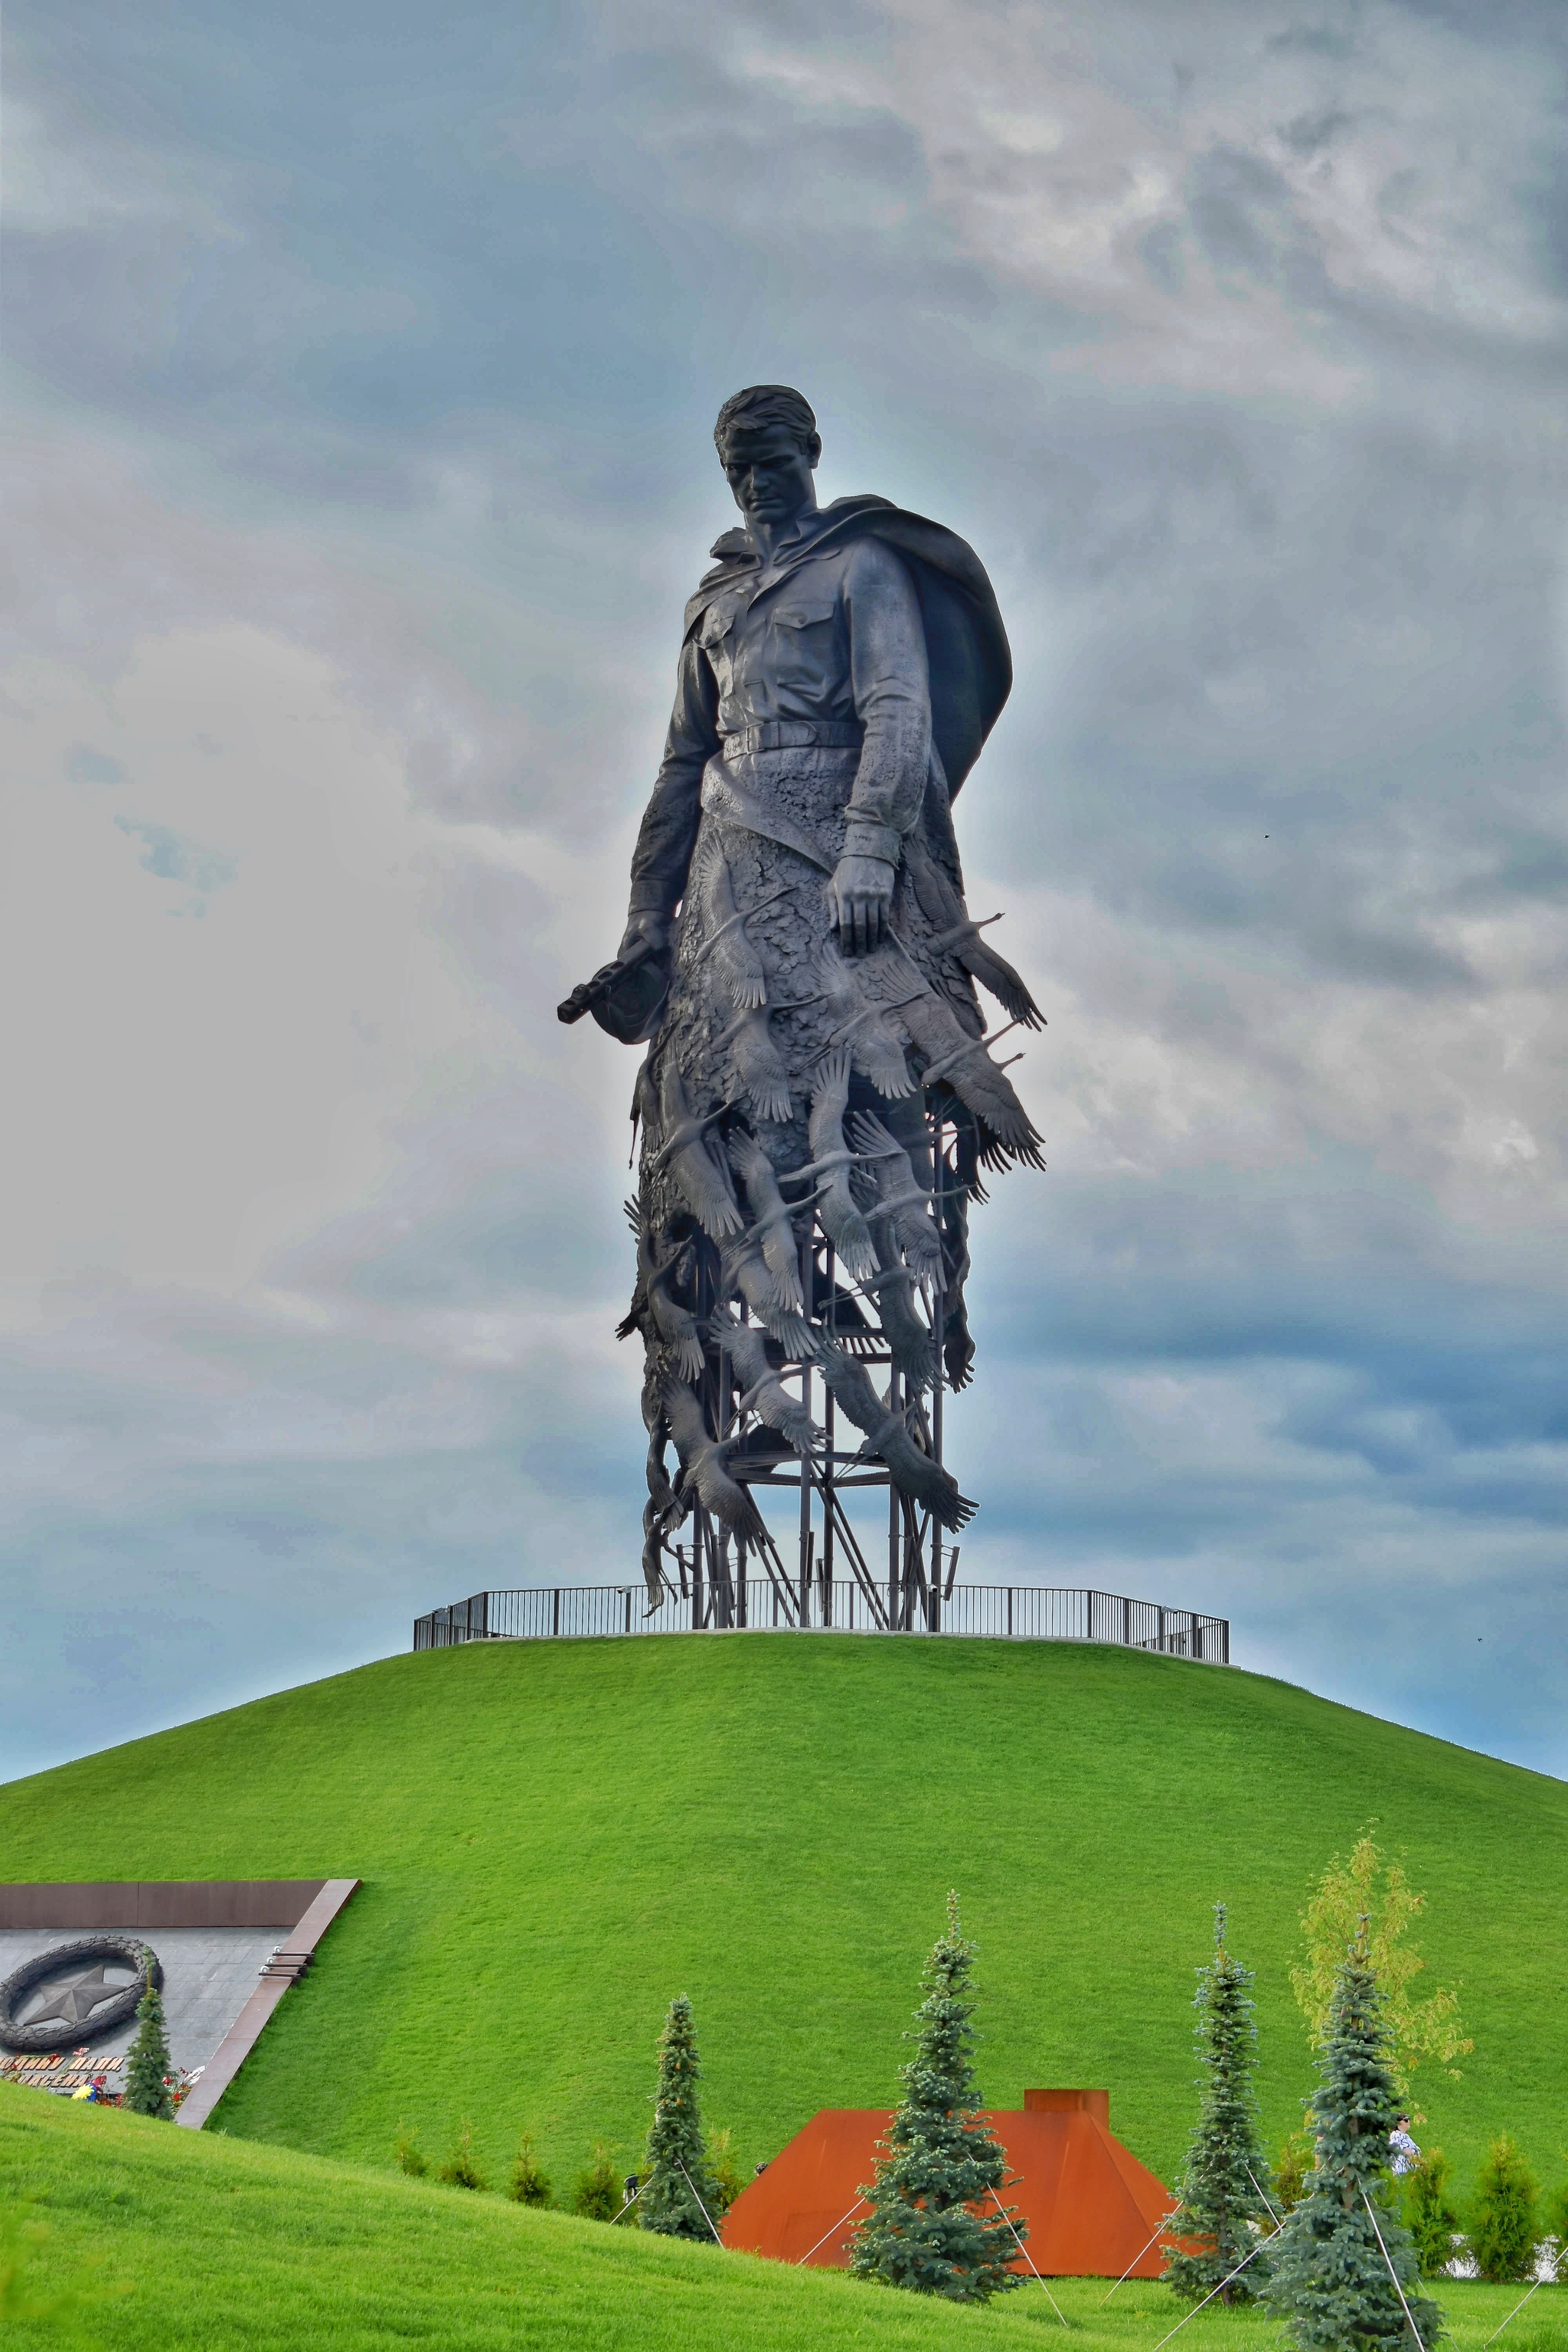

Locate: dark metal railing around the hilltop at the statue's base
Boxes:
[413,1578,1230,1665]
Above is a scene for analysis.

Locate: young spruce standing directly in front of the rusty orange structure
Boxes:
[848,1896,1023,2302]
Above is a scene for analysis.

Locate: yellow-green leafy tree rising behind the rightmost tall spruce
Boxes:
[1291,1823,1474,2124]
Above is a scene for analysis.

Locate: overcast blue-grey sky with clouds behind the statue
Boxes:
[0,0,1568,1769]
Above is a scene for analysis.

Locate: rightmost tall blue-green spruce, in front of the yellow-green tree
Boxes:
[1263,1933,1443,2352]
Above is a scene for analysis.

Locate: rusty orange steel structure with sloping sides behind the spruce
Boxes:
[724,2091,1175,2279]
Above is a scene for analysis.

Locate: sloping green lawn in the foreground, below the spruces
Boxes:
[0,2084,1568,2352]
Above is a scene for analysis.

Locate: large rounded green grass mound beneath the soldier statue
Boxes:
[0,1635,1568,2180]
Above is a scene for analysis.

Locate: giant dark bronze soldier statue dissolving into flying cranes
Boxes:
[560,384,1041,1623]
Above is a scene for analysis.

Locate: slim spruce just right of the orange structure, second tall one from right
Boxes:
[1164,1903,1274,2302]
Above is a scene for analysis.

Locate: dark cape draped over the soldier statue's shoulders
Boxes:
[687,496,1013,799]
